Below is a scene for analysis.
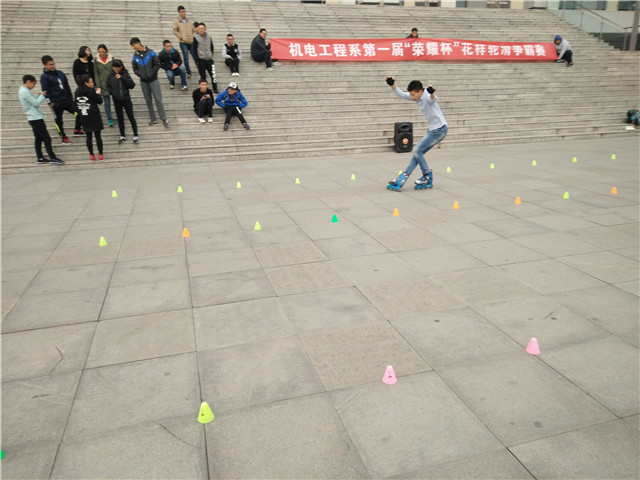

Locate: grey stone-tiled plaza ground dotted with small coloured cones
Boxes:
[0,135,639,479]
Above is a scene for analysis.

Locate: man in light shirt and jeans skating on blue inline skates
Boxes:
[385,77,448,190]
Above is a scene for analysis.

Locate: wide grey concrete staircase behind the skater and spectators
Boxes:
[0,0,640,173]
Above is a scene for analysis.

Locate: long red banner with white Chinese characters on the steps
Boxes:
[271,38,558,62]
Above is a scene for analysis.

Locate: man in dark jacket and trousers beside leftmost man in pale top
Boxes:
[40,55,84,145]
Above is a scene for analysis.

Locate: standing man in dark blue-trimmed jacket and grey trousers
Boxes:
[129,37,169,128]
